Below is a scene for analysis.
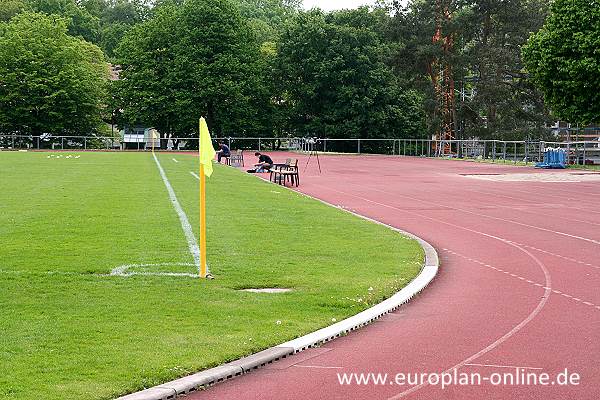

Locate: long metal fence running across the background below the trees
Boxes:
[0,135,600,165]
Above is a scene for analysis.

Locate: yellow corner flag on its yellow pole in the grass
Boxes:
[198,118,216,278]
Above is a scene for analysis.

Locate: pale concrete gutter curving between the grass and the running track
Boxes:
[117,188,439,400]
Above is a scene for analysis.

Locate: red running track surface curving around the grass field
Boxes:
[188,153,600,400]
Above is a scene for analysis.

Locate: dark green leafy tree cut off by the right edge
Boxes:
[523,0,600,124]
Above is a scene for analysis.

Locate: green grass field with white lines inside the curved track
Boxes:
[0,152,423,400]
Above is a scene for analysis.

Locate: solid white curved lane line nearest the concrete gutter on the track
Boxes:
[302,185,552,400]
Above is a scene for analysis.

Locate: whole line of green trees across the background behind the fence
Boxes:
[0,0,600,139]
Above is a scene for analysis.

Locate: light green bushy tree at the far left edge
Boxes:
[0,12,108,136]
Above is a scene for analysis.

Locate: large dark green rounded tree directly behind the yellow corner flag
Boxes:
[115,0,270,136]
